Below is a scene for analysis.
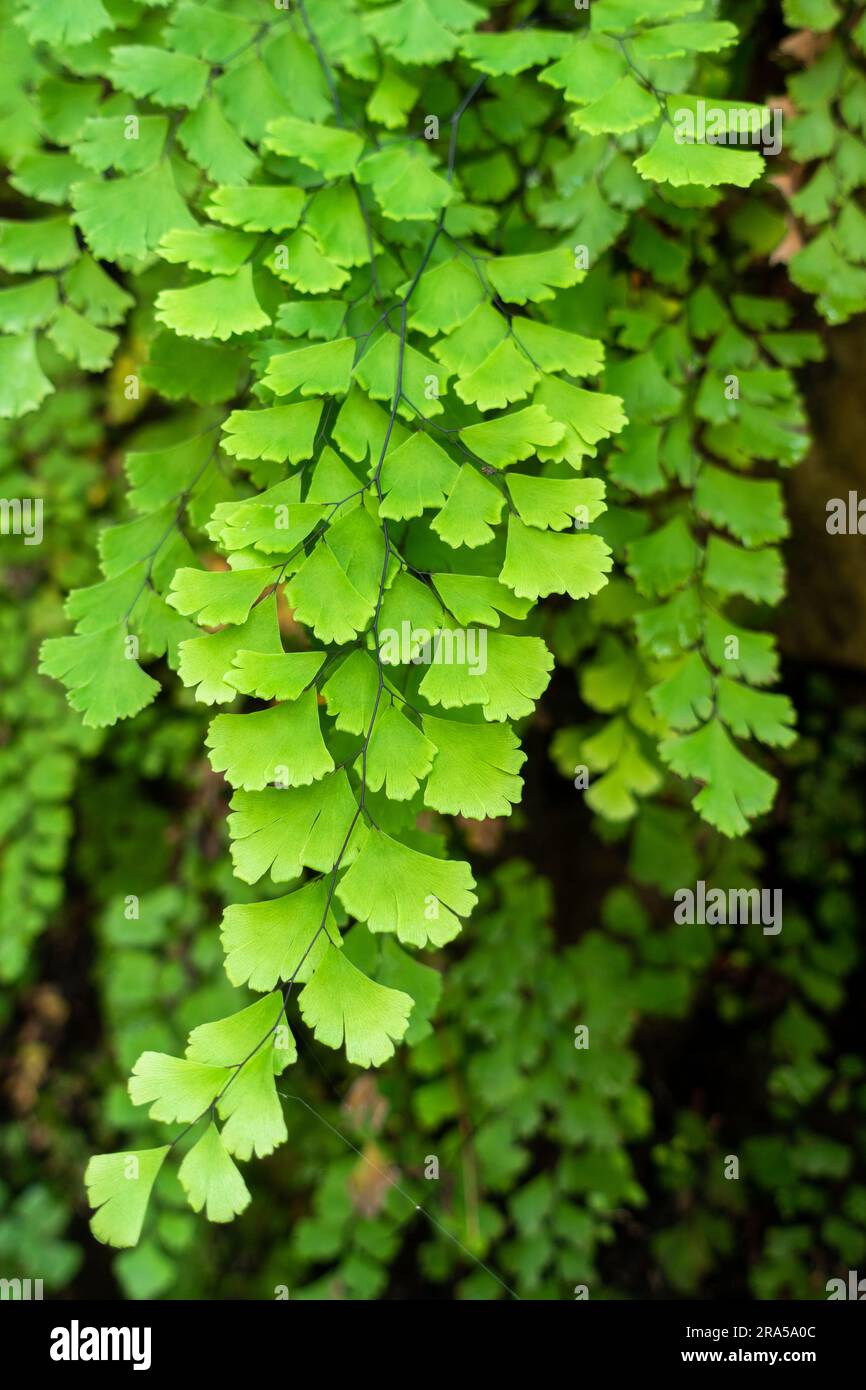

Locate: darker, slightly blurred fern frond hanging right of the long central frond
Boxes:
[553,180,820,835]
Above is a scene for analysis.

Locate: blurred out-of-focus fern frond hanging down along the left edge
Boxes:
[0,378,104,984]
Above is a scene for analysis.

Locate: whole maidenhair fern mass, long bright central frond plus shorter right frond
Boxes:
[0,0,834,1245]
